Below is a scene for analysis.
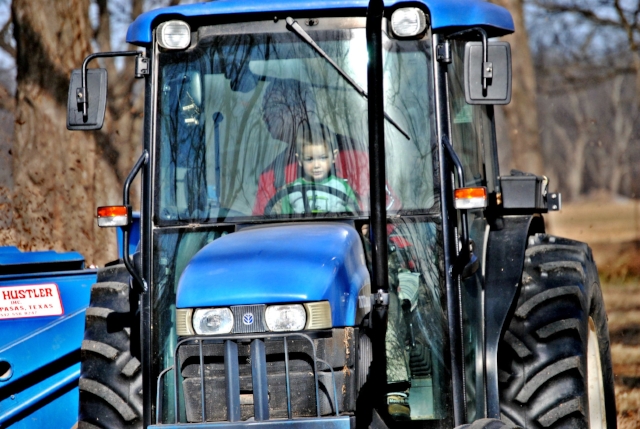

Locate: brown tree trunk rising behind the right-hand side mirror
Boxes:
[491,0,545,174]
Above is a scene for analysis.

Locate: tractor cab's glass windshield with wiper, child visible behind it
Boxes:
[154,18,436,225]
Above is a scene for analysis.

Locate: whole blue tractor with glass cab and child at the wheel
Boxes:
[67,0,616,429]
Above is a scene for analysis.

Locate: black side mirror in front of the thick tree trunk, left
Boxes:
[67,69,107,130]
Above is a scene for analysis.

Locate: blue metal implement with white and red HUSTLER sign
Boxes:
[0,247,96,429]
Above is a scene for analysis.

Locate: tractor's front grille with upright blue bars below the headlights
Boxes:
[157,330,357,423]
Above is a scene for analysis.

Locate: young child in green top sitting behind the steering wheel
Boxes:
[282,125,359,214]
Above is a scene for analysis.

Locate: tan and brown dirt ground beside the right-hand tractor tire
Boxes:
[546,198,640,429]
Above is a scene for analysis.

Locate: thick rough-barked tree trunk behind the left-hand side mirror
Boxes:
[12,0,117,263]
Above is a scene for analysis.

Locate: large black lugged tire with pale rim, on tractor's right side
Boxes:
[498,234,616,429]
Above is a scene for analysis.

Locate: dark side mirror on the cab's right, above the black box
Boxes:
[464,42,511,104]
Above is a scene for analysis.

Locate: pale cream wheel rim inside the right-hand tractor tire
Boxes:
[587,317,607,428]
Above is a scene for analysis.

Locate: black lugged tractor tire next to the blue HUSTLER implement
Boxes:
[78,267,142,429]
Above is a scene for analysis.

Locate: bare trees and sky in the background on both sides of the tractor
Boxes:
[0,0,640,265]
